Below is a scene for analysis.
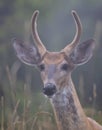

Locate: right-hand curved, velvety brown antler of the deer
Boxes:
[63,10,82,53]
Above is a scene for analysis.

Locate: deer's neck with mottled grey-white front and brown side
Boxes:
[52,79,88,130]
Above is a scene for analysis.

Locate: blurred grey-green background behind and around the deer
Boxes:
[0,0,102,130]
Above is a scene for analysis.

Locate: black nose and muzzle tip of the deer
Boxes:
[43,83,56,97]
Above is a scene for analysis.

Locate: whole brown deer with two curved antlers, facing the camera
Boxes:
[13,11,102,130]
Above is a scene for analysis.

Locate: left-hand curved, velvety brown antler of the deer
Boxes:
[31,10,46,55]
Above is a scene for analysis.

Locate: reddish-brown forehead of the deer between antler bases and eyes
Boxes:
[43,52,64,64]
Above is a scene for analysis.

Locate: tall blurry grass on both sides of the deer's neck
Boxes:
[0,67,102,130]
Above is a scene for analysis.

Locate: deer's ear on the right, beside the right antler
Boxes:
[69,39,95,65]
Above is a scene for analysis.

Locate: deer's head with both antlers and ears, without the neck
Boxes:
[13,11,94,97]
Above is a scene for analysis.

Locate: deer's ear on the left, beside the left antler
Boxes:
[13,39,41,66]
